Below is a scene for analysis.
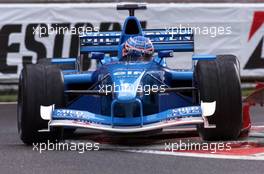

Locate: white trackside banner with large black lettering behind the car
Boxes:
[0,3,264,79]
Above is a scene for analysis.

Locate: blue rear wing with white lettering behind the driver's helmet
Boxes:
[80,28,194,54]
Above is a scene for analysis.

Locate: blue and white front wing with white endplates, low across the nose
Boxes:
[39,102,215,133]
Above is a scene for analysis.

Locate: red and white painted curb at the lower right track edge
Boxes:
[120,126,264,160]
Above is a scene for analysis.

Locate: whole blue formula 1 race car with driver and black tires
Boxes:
[17,4,243,144]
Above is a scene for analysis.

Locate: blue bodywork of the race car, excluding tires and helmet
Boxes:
[49,8,216,126]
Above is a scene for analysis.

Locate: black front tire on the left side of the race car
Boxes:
[17,64,65,145]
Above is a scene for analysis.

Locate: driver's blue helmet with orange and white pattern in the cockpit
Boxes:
[122,36,154,61]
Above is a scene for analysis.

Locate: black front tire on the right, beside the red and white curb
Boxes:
[195,56,242,141]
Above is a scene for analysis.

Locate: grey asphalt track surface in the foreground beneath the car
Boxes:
[0,104,264,174]
